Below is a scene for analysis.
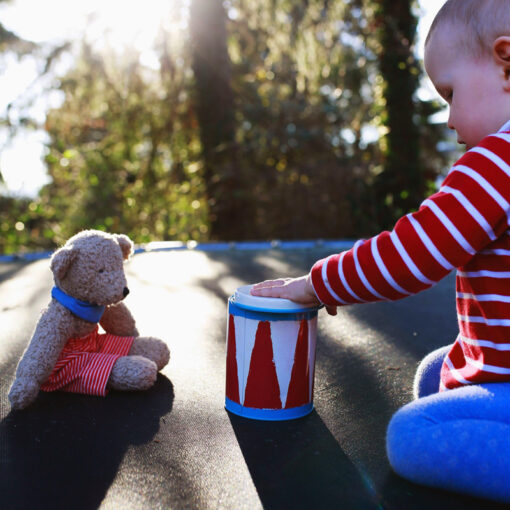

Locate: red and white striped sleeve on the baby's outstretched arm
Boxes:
[311,133,510,306]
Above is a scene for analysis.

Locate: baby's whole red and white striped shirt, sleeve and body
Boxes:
[311,122,510,390]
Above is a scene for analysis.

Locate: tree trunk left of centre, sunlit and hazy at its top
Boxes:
[190,0,245,240]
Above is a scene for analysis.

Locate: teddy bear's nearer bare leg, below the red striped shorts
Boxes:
[108,356,158,391]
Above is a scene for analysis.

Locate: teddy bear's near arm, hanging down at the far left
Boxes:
[9,305,69,409]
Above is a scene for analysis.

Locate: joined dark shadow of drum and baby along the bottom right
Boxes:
[228,410,508,510]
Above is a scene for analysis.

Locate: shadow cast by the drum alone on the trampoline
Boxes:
[229,411,381,509]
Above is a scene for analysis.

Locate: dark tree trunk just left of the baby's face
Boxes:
[375,0,425,228]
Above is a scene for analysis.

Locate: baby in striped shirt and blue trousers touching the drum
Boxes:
[252,0,510,502]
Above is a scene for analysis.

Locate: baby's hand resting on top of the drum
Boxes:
[250,275,336,315]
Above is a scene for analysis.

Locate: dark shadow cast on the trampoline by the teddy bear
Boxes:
[0,374,174,509]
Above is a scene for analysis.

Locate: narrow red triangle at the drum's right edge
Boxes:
[285,320,310,409]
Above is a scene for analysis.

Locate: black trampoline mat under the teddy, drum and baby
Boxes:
[0,248,503,510]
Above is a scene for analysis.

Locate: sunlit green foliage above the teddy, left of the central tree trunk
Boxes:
[37,33,208,247]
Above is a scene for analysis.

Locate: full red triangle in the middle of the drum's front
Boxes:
[244,321,282,409]
